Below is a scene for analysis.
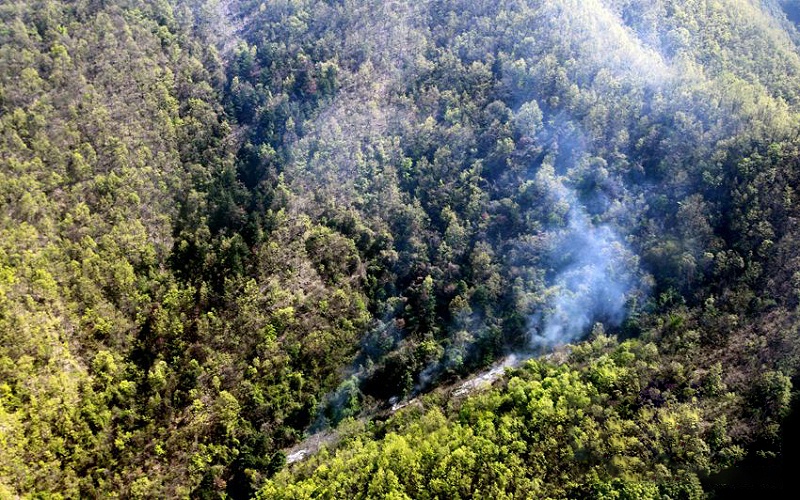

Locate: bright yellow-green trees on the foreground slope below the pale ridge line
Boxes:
[259,337,741,498]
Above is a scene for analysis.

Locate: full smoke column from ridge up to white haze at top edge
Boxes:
[516,0,664,351]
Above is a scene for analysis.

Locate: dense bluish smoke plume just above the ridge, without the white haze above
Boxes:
[529,101,652,352]
